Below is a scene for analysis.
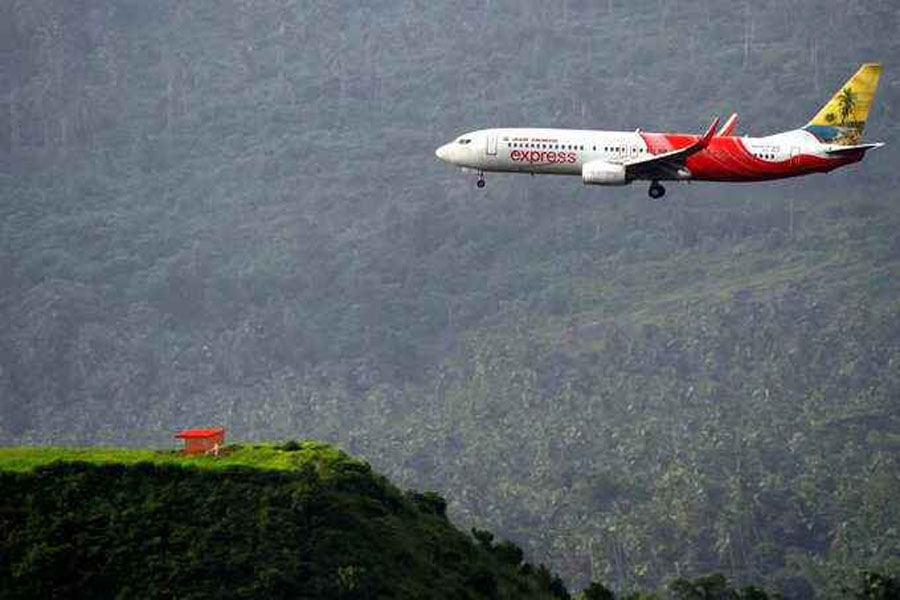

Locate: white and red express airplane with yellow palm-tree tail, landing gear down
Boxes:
[435,63,884,199]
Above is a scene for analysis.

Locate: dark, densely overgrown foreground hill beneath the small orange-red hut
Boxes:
[0,443,568,600]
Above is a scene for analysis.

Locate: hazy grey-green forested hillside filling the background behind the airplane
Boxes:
[0,0,900,597]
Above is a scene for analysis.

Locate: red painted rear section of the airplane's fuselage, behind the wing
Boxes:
[641,133,864,181]
